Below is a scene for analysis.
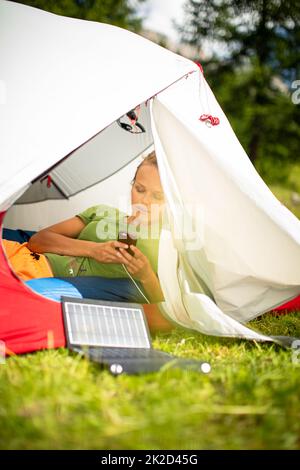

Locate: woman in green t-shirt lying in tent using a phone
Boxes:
[3,152,174,331]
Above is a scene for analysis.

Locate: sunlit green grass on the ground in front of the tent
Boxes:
[0,312,300,450]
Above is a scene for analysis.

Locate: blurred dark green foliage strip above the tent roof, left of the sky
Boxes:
[16,0,146,32]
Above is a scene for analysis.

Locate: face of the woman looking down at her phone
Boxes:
[131,163,165,224]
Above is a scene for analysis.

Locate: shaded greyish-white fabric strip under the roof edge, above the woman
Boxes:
[16,104,153,204]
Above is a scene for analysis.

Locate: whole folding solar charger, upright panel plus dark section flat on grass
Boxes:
[62,297,211,375]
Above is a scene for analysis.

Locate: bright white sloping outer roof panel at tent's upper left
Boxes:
[0,0,198,210]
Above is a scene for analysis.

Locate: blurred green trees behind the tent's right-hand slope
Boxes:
[177,0,300,179]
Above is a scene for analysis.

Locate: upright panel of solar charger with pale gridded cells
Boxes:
[64,301,151,348]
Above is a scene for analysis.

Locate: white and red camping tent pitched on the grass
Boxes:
[0,0,300,353]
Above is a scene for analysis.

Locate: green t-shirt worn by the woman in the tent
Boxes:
[44,204,161,278]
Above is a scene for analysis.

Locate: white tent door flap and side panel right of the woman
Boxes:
[151,74,300,339]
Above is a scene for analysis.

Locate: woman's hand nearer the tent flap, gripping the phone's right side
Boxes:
[120,245,155,283]
